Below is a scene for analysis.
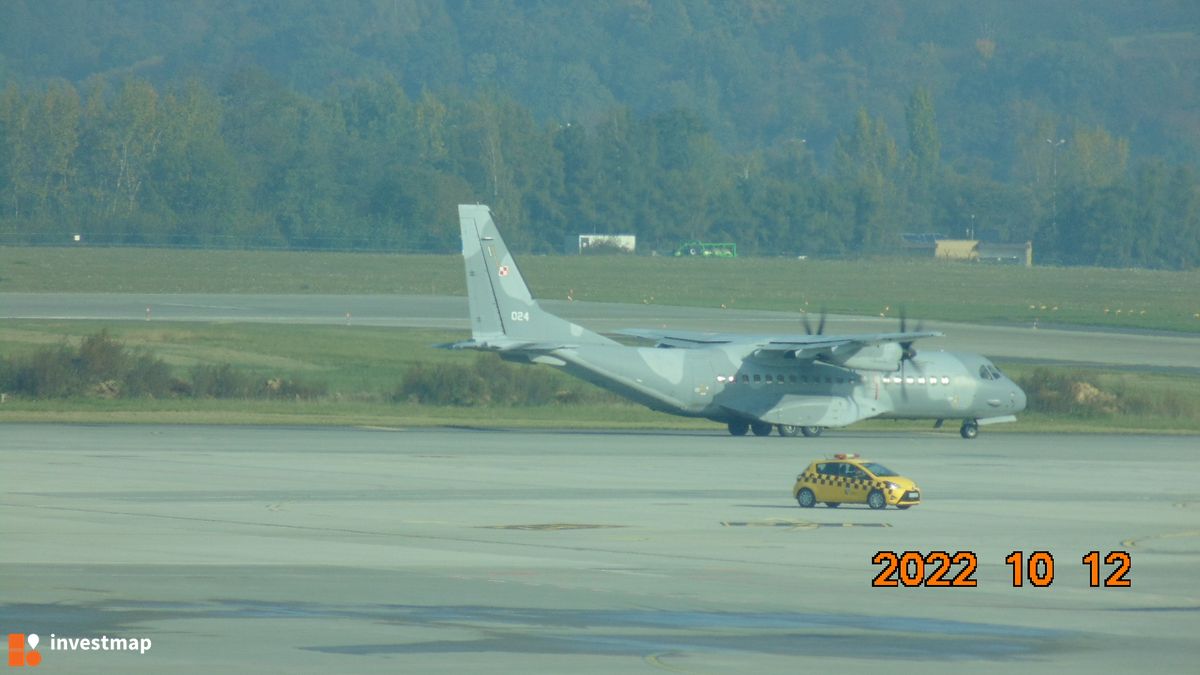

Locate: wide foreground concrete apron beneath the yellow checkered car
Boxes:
[0,424,1200,674]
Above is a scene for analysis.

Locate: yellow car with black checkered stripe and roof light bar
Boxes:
[792,454,920,508]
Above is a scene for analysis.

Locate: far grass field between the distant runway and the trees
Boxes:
[0,247,1200,333]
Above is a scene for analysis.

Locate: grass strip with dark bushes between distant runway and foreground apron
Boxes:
[0,321,1200,434]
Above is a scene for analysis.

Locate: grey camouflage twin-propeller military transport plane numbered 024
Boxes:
[444,204,1025,438]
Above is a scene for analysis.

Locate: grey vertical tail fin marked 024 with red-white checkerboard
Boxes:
[458,204,616,350]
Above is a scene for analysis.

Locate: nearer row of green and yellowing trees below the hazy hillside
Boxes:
[0,74,1200,269]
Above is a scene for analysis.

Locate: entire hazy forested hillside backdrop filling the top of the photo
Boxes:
[0,0,1200,268]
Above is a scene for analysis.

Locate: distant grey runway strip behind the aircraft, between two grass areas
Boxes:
[0,293,1200,374]
